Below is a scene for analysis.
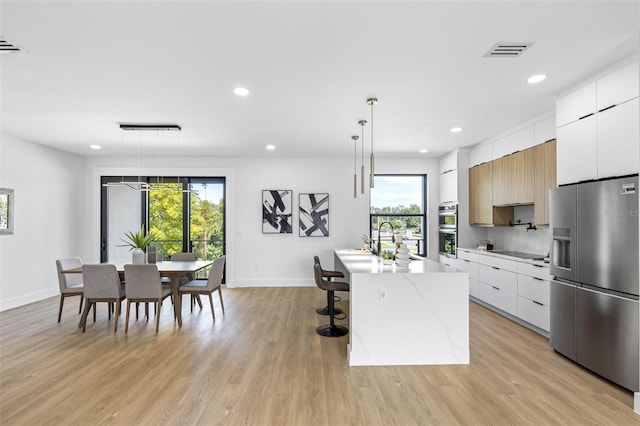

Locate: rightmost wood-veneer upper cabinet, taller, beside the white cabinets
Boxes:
[532,139,556,225]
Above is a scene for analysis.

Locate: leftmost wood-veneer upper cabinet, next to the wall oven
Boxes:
[469,162,493,225]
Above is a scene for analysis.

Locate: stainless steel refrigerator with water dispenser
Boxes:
[550,175,640,392]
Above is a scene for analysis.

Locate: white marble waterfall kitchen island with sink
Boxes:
[334,249,469,366]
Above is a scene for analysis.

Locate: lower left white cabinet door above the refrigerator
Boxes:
[556,115,598,185]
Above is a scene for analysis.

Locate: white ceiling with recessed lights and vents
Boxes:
[0,0,640,157]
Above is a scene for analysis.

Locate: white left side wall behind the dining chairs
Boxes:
[0,134,85,312]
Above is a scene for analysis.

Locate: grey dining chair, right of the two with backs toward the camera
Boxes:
[124,264,171,333]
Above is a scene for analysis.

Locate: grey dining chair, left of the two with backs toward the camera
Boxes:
[80,264,125,333]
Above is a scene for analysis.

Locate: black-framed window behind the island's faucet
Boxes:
[369,175,427,256]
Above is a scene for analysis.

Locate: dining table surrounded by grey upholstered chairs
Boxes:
[62,260,213,327]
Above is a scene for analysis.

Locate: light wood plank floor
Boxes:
[0,288,640,426]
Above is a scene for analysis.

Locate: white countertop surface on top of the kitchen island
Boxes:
[335,249,458,274]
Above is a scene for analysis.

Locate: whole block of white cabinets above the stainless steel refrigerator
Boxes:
[556,62,640,185]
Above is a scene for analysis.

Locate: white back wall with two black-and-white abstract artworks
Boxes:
[86,154,438,287]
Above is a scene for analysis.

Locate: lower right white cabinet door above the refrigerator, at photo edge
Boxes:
[596,98,640,178]
